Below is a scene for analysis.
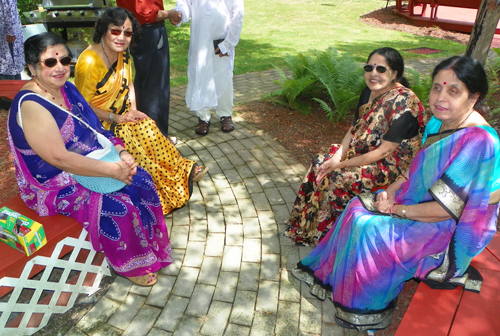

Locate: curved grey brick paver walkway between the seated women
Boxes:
[68,61,446,336]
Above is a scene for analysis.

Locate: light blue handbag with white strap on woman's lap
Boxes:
[64,110,126,194]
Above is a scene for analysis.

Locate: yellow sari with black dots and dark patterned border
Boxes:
[75,49,195,214]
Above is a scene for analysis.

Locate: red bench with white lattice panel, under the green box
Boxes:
[0,196,111,335]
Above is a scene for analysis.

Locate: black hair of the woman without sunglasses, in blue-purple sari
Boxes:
[432,56,489,116]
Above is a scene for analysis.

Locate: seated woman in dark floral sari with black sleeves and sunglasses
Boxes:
[285,47,428,246]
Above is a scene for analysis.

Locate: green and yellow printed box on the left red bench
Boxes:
[0,207,47,256]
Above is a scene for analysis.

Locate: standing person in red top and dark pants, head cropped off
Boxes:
[116,0,178,139]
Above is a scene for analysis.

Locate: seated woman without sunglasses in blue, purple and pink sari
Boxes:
[292,56,500,330]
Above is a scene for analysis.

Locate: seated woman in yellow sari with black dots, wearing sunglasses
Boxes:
[75,7,208,214]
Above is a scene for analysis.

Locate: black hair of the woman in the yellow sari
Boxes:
[92,7,141,45]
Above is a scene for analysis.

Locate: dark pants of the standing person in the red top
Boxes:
[130,22,170,136]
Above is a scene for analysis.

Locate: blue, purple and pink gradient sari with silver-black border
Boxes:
[292,122,500,330]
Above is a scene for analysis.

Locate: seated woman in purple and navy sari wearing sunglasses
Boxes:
[8,33,172,286]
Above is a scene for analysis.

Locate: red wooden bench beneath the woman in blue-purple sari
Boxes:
[395,233,500,336]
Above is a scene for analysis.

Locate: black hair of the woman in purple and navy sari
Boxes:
[24,32,73,73]
